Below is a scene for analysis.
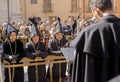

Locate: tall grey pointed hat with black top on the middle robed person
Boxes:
[29,17,40,38]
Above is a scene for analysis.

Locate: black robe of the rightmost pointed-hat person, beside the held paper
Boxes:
[47,37,68,81]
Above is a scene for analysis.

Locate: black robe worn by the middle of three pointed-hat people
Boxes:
[25,42,47,82]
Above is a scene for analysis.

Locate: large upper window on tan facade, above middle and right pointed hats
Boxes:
[43,0,52,12]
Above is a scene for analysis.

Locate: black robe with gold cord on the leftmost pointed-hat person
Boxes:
[3,40,25,82]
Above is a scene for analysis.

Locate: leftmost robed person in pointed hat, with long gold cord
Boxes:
[3,23,25,82]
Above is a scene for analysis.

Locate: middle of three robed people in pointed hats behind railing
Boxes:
[25,19,47,82]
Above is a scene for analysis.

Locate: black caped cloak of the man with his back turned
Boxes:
[70,15,120,82]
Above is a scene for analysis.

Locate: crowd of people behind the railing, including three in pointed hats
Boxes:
[0,13,86,82]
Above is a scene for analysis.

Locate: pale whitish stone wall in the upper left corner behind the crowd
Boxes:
[0,0,22,24]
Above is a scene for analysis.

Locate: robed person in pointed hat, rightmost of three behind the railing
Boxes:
[47,18,68,82]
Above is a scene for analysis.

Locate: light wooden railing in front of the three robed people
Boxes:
[0,55,66,82]
